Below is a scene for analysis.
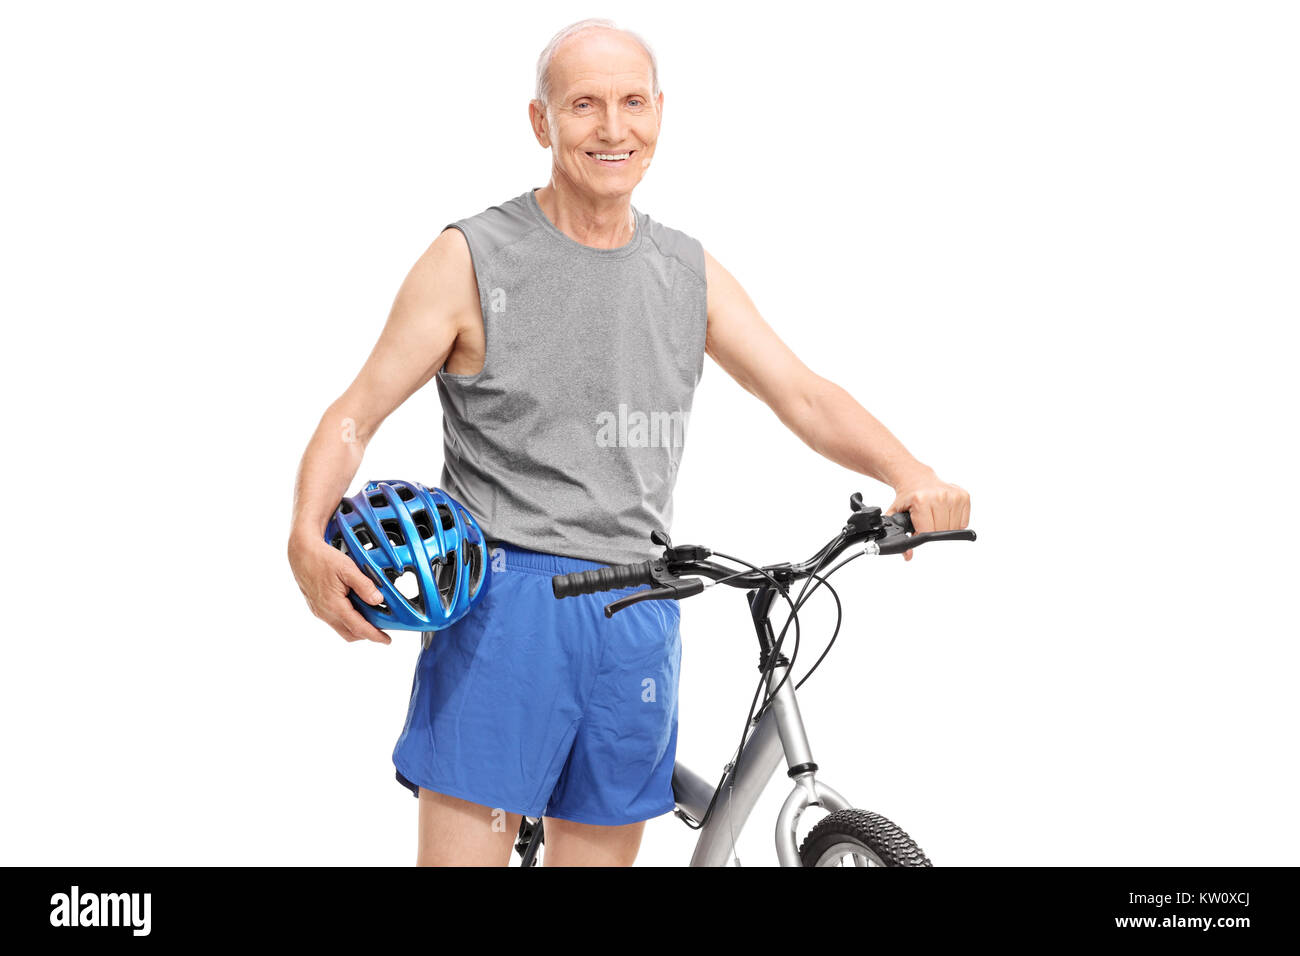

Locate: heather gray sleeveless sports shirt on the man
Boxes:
[437,190,707,563]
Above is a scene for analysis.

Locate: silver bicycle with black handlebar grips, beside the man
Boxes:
[515,493,975,866]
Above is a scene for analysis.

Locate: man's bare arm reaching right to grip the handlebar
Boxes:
[705,252,970,561]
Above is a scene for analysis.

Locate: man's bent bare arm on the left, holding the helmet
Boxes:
[289,229,482,644]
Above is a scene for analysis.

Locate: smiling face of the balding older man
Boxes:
[529,30,663,199]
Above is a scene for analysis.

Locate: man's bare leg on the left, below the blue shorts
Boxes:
[416,787,517,866]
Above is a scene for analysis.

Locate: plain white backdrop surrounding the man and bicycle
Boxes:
[0,1,1300,865]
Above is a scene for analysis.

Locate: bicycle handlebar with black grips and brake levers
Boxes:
[551,493,975,618]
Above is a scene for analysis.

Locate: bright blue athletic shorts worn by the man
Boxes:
[393,542,681,826]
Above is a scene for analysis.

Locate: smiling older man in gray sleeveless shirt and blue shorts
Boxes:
[289,21,970,865]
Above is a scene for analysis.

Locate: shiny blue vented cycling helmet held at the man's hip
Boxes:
[325,481,491,631]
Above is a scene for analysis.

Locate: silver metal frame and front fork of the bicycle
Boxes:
[672,665,849,866]
